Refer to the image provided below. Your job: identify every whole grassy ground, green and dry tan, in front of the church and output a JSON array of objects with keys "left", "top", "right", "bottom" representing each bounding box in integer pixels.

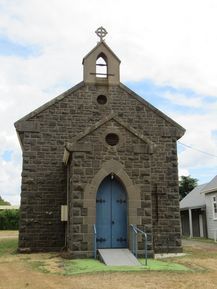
[{"left": 0, "top": 232, "right": 217, "bottom": 289}]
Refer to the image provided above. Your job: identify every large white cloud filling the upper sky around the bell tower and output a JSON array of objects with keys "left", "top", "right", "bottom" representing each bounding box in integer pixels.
[{"left": 0, "top": 0, "right": 217, "bottom": 96}]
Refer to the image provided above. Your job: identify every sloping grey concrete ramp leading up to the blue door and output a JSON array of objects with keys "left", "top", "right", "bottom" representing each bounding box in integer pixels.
[{"left": 98, "top": 249, "right": 141, "bottom": 266}]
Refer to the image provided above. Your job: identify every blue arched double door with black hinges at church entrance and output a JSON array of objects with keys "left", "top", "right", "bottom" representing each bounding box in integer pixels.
[{"left": 96, "top": 176, "right": 127, "bottom": 248}]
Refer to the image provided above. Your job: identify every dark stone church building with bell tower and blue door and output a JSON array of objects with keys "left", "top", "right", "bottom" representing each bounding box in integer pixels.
[{"left": 15, "top": 27, "right": 185, "bottom": 258}]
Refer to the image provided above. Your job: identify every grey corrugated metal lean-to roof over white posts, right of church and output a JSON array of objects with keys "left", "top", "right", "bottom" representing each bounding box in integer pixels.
[{"left": 180, "top": 183, "right": 207, "bottom": 209}]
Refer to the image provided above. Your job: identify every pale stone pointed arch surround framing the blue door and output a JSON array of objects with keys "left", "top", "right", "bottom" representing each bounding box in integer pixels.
[{"left": 84, "top": 160, "right": 141, "bottom": 232}]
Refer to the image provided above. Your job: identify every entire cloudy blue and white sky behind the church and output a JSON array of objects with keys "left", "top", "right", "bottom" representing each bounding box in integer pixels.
[{"left": 0, "top": 0, "right": 217, "bottom": 205}]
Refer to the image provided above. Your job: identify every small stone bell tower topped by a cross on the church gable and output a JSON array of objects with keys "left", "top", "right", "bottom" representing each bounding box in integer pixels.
[{"left": 83, "top": 27, "right": 121, "bottom": 85}]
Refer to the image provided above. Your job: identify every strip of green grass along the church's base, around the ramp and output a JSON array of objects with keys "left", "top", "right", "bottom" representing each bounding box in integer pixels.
[{"left": 0, "top": 234, "right": 191, "bottom": 275}]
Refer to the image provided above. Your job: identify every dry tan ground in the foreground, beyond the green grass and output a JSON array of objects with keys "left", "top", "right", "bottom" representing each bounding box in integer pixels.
[{"left": 0, "top": 235, "right": 217, "bottom": 289}]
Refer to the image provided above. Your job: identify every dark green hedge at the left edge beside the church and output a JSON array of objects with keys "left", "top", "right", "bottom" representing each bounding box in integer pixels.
[{"left": 0, "top": 209, "right": 20, "bottom": 230}]
